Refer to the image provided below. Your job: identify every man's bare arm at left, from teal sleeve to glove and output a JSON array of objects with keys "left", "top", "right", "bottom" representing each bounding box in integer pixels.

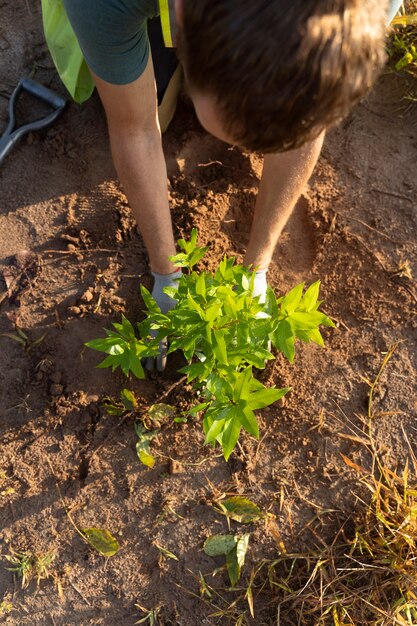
[{"left": 94, "top": 57, "right": 176, "bottom": 274}]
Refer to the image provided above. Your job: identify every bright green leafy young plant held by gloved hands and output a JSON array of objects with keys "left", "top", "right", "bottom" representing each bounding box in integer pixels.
[{"left": 86, "top": 230, "right": 334, "bottom": 460}]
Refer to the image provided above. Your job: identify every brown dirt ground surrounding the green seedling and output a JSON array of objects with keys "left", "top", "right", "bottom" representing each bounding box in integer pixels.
[{"left": 0, "top": 0, "right": 417, "bottom": 626}]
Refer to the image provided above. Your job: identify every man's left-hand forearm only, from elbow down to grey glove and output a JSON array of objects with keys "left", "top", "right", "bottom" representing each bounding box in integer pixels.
[{"left": 109, "top": 127, "right": 176, "bottom": 274}]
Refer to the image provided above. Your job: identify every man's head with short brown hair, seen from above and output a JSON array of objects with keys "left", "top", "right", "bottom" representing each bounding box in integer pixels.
[{"left": 177, "top": 0, "right": 387, "bottom": 152}]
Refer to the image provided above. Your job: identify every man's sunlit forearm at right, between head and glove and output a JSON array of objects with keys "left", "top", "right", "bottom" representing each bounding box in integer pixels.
[{"left": 244, "top": 133, "right": 324, "bottom": 268}]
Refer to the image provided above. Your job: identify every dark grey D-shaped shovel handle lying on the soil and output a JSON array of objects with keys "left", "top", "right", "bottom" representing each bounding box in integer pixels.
[{"left": 0, "top": 78, "right": 67, "bottom": 165}]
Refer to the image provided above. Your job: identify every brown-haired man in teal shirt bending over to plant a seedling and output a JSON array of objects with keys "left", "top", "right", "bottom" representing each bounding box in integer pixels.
[{"left": 58, "top": 0, "right": 400, "bottom": 369}]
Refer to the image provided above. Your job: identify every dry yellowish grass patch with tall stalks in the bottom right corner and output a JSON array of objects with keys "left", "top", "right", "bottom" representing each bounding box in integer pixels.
[{"left": 185, "top": 344, "right": 417, "bottom": 626}]
